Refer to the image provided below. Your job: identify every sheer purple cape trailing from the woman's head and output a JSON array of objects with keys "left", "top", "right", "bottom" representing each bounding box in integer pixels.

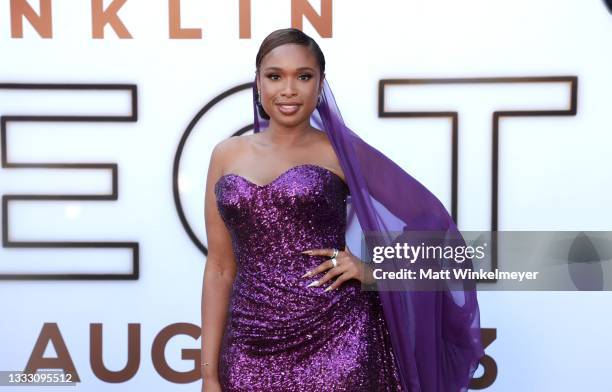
[{"left": 253, "top": 79, "right": 484, "bottom": 392}]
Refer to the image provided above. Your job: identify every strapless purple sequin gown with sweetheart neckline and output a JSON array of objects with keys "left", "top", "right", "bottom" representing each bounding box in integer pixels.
[{"left": 215, "top": 164, "right": 401, "bottom": 392}]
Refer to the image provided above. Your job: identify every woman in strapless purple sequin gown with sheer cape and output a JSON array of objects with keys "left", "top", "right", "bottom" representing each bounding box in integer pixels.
[{"left": 202, "top": 29, "right": 482, "bottom": 392}]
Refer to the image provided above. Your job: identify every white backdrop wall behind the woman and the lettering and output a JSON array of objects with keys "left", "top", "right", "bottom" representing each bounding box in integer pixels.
[{"left": 0, "top": 0, "right": 612, "bottom": 391}]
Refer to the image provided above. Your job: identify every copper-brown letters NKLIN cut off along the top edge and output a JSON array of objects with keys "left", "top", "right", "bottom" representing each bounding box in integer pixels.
[{"left": 9, "top": 0, "right": 332, "bottom": 39}]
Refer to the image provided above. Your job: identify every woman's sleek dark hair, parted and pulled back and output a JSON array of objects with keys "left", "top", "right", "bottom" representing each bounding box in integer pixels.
[{"left": 255, "top": 28, "right": 325, "bottom": 120}]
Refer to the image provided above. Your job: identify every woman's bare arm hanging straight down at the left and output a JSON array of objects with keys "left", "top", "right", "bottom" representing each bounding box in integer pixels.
[{"left": 201, "top": 140, "right": 236, "bottom": 389}]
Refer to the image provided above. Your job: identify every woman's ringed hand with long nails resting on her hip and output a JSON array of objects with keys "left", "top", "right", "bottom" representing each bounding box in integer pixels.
[{"left": 302, "top": 246, "right": 374, "bottom": 291}]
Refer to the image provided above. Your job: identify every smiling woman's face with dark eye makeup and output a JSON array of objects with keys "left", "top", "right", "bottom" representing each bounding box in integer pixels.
[{"left": 257, "top": 44, "right": 322, "bottom": 126}]
